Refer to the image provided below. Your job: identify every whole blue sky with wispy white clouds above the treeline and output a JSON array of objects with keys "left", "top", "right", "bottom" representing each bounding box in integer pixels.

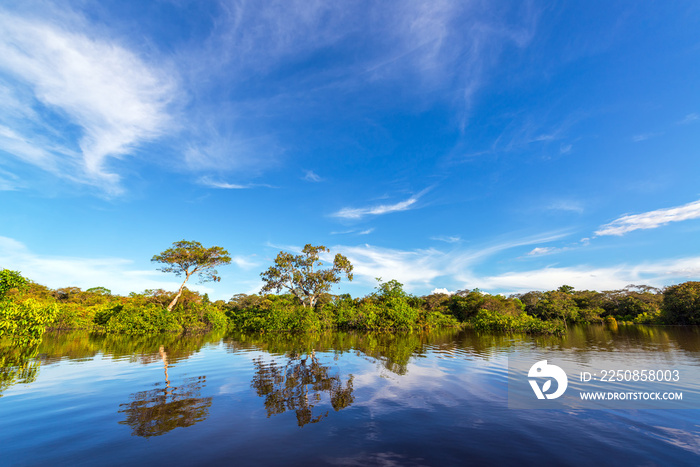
[{"left": 0, "top": 0, "right": 700, "bottom": 299}]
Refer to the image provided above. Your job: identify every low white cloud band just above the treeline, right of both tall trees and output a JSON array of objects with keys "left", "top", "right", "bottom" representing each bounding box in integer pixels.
[{"left": 262, "top": 233, "right": 700, "bottom": 293}]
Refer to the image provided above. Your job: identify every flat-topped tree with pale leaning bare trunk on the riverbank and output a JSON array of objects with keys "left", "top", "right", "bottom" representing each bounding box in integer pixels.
[{"left": 151, "top": 240, "right": 231, "bottom": 311}]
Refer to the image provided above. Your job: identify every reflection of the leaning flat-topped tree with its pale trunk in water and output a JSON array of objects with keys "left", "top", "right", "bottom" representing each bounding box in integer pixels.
[{"left": 119, "top": 346, "right": 212, "bottom": 438}]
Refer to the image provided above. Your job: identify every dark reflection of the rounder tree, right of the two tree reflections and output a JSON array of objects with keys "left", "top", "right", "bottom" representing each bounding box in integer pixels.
[{"left": 252, "top": 352, "right": 355, "bottom": 427}]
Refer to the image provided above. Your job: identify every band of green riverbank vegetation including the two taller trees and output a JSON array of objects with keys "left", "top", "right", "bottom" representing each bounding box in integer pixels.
[{"left": 0, "top": 240, "right": 700, "bottom": 340}]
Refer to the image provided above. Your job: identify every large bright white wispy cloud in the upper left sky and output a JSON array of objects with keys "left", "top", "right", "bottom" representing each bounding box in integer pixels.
[{"left": 0, "top": 10, "right": 178, "bottom": 193}]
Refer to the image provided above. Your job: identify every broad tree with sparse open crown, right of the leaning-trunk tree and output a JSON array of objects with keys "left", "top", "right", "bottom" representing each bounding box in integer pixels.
[{"left": 260, "top": 244, "right": 352, "bottom": 308}]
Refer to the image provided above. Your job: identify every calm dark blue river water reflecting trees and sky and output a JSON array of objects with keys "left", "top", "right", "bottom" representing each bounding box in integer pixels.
[{"left": 0, "top": 326, "right": 700, "bottom": 466}]
